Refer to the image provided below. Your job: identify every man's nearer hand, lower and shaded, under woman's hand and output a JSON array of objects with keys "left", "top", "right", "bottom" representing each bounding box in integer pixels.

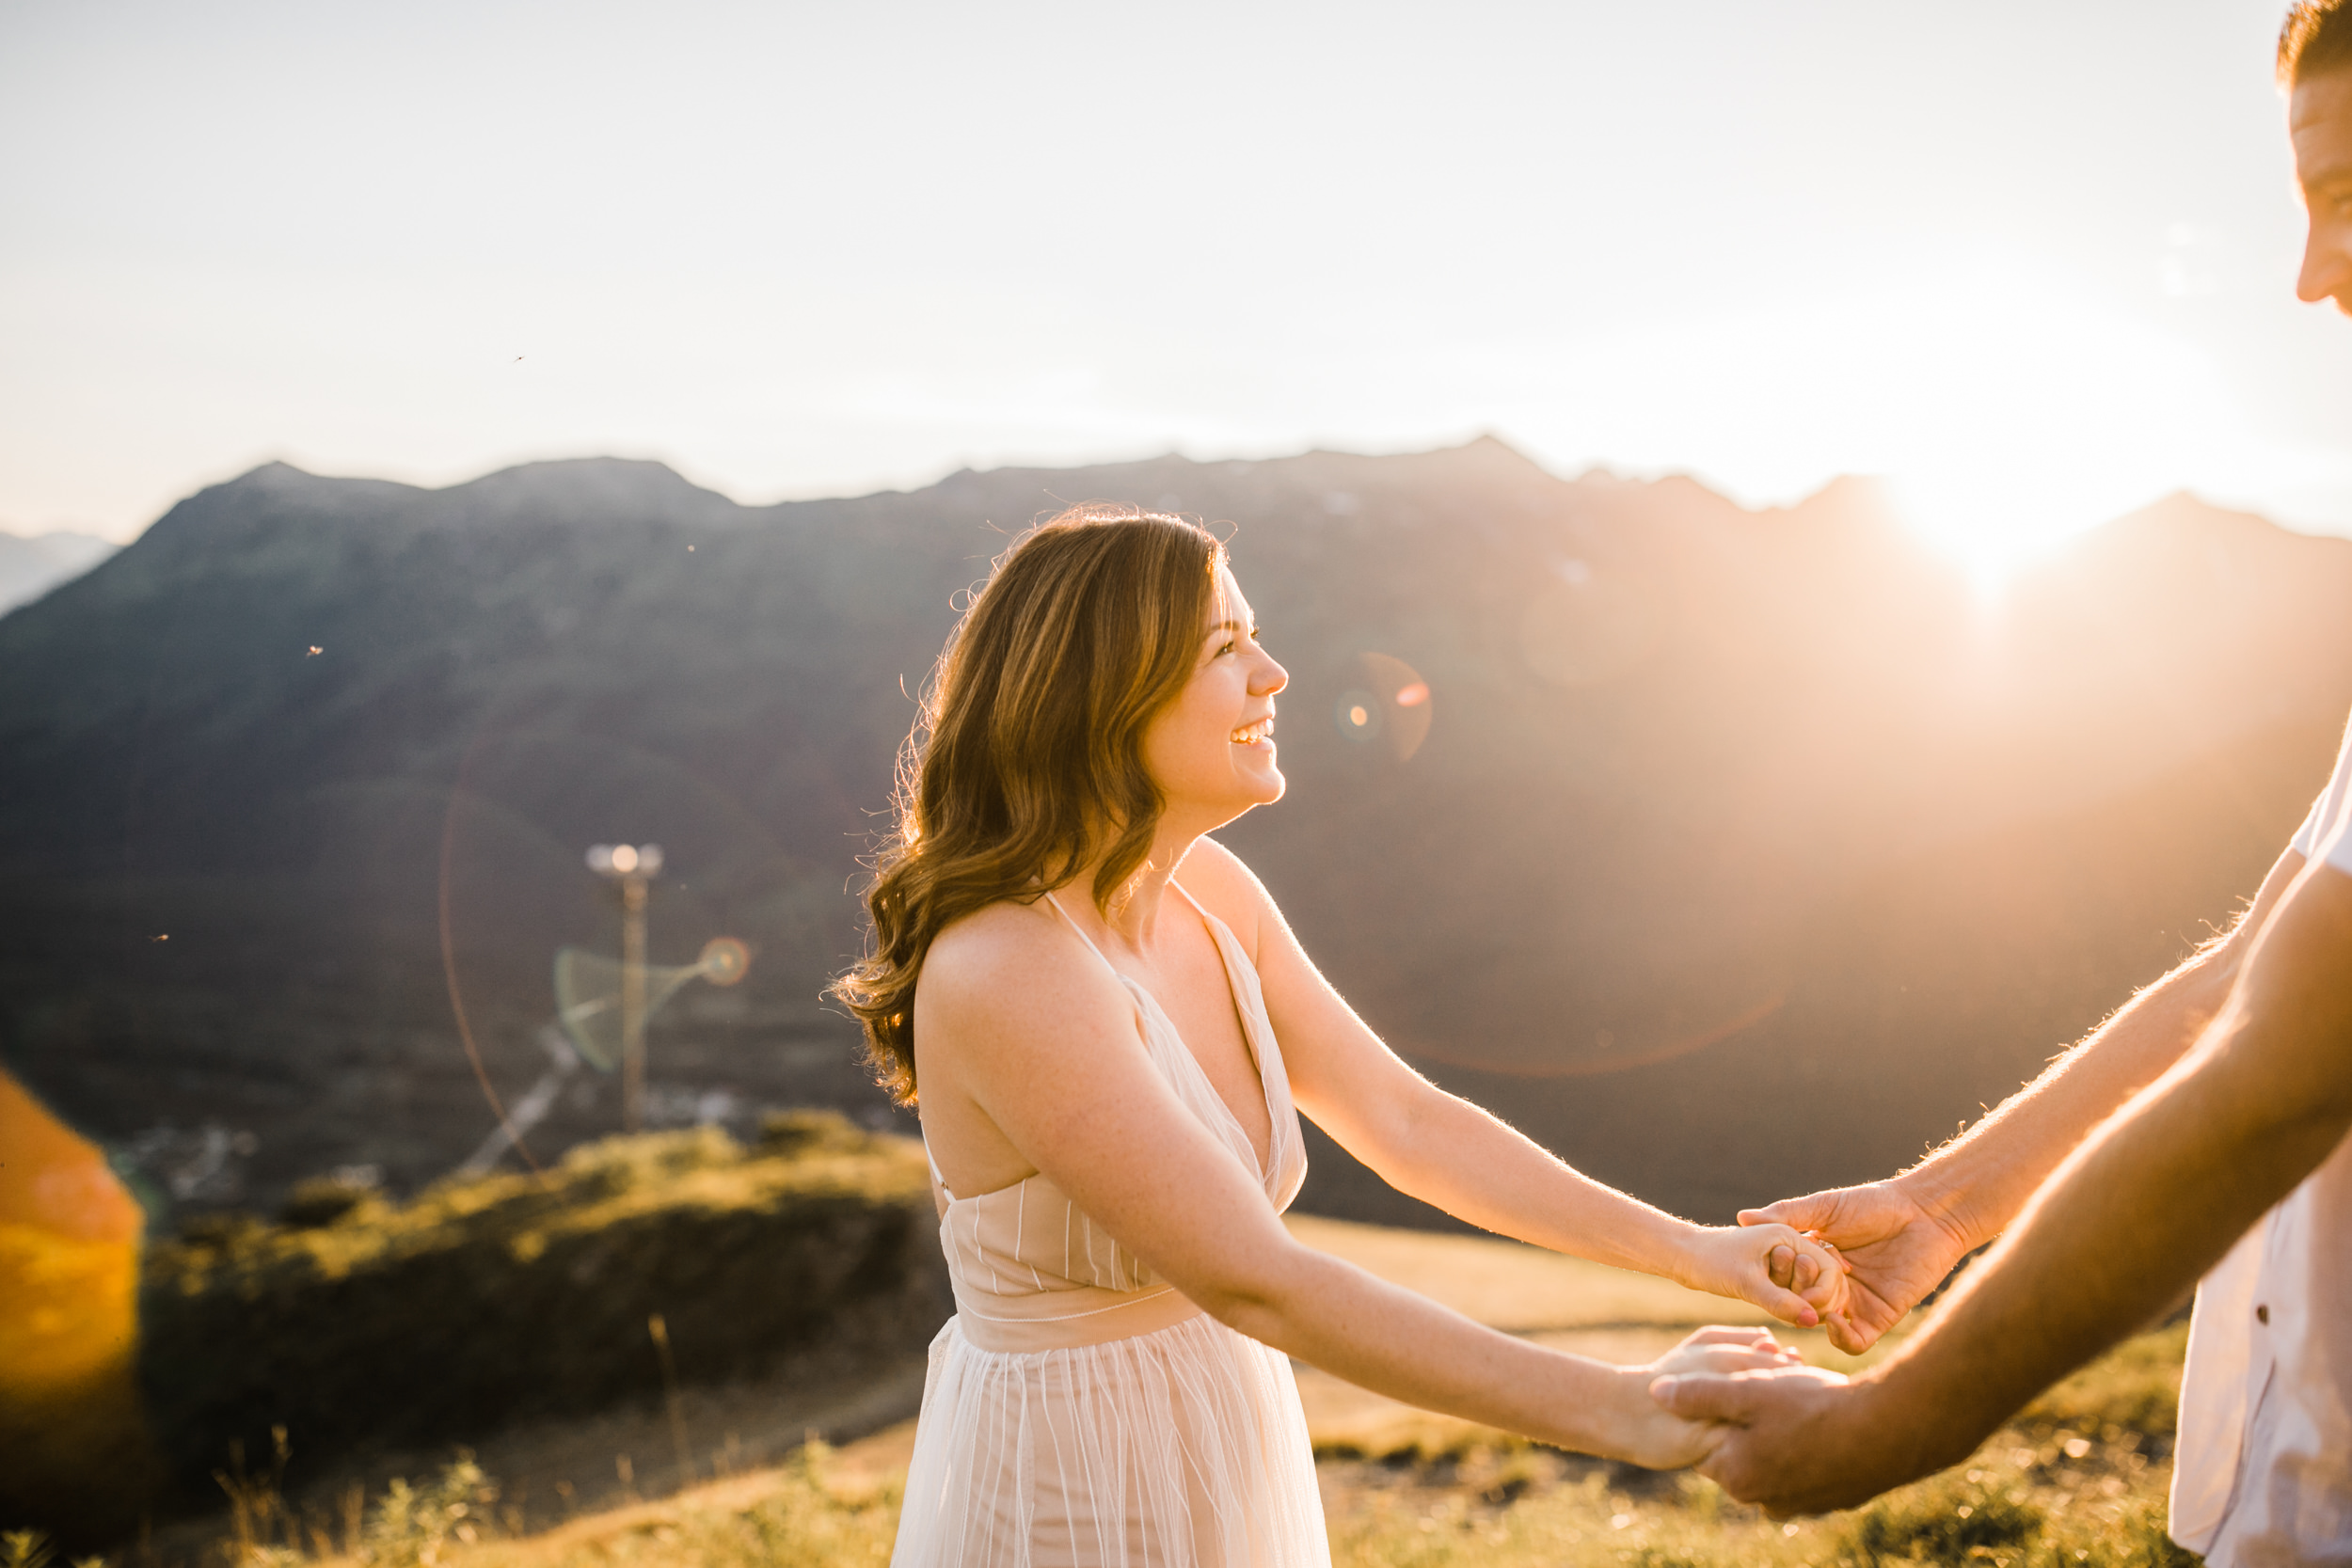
[{"left": 1649, "top": 1366, "right": 1936, "bottom": 1519}]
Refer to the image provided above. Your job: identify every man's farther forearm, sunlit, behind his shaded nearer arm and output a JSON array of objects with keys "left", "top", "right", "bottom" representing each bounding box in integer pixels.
[{"left": 1896, "top": 851, "right": 2303, "bottom": 1246}]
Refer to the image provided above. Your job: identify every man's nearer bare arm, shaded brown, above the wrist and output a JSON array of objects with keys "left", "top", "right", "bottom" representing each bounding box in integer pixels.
[{"left": 1866, "top": 867, "right": 2352, "bottom": 1472}]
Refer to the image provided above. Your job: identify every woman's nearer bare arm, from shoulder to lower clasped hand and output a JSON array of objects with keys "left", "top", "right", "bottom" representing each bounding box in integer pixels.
[{"left": 915, "top": 908, "right": 1783, "bottom": 1467}]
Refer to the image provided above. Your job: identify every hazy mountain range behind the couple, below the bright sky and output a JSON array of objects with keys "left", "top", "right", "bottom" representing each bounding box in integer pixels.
[{"left": 0, "top": 439, "right": 2352, "bottom": 1218}]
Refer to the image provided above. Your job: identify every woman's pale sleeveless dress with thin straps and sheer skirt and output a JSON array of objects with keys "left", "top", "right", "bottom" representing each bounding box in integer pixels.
[{"left": 892, "top": 884, "right": 1331, "bottom": 1568}]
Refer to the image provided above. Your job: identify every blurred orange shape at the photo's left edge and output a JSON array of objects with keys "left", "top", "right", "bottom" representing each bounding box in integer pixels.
[{"left": 0, "top": 1072, "right": 146, "bottom": 1540}]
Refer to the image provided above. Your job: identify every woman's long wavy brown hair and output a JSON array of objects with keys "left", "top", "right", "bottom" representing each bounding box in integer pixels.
[{"left": 828, "top": 503, "right": 1226, "bottom": 1105}]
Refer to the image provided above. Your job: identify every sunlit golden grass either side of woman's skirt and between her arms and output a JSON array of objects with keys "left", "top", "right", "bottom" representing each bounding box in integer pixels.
[{"left": 96, "top": 1220, "right": 2190, "bottom": 1568}]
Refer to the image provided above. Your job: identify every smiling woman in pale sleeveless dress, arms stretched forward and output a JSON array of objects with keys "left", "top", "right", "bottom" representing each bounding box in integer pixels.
[{"left": 835, "top": 508, "right": 1844, "bottom": 1568}]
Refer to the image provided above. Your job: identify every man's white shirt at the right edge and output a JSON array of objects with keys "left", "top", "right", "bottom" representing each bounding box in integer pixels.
[{"left": 2171, "top": 714, "right": 2352, "bottom": 1568}]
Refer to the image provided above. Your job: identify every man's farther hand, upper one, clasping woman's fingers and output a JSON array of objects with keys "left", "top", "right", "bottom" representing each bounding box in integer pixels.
[{"left": 1740, "top": 1180, "right": 1969, "bottom": 1356}]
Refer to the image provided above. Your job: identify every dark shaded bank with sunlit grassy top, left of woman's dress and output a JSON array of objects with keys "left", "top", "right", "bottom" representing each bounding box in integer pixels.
[{"left": 139, "top": 1115, "right": 948, "bottom": 1496}]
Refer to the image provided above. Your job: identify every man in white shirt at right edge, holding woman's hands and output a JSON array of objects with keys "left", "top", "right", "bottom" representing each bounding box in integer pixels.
[{"left": 1654, "top": 0, "right": 2352, "bottom": 1568}]
